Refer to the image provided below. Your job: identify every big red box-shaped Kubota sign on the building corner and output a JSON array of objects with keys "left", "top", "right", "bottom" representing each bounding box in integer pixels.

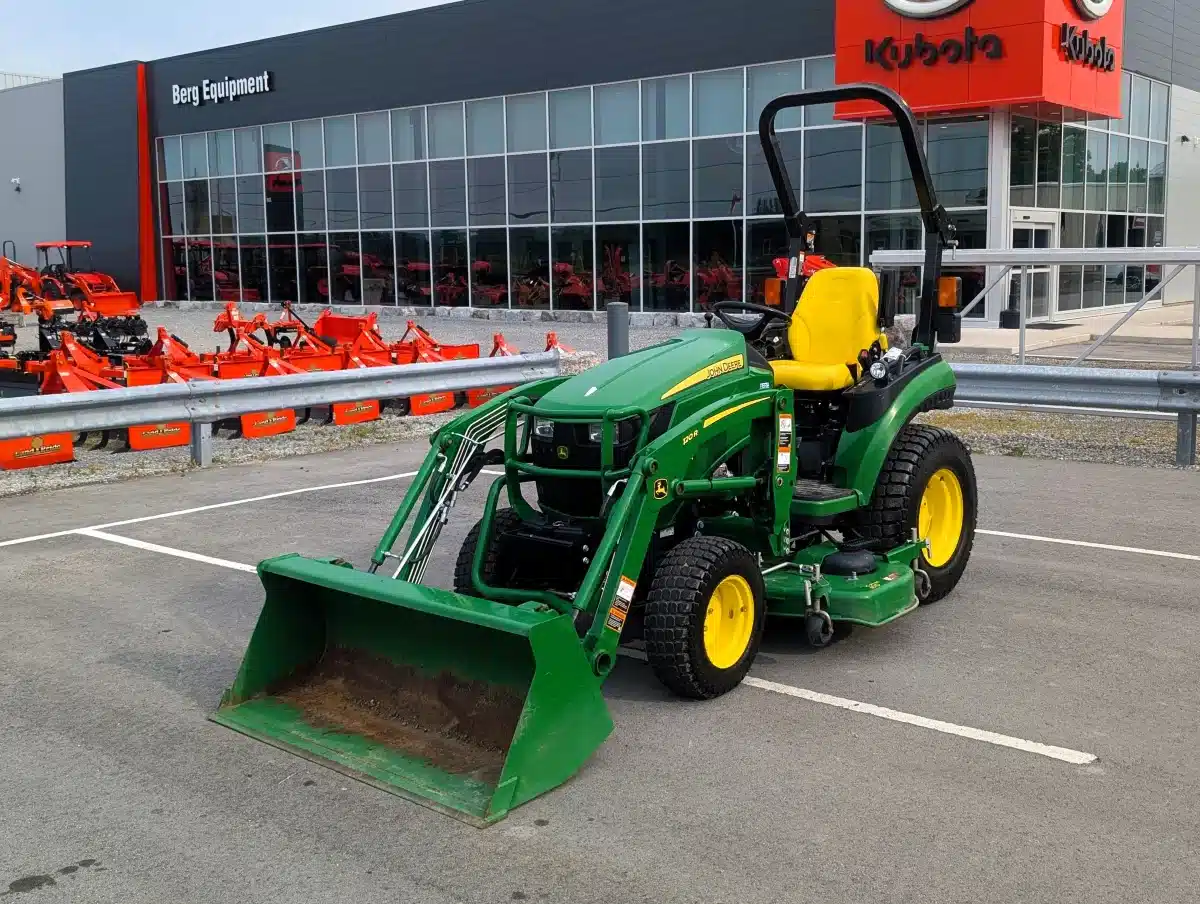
[{"left": 836, "top": 0, "right": 1124, "bottom": 116}]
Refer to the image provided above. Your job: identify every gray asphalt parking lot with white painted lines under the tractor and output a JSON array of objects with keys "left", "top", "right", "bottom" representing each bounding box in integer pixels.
[{"left": 0, "top": 443, "right": 1200, "bottom": 904}]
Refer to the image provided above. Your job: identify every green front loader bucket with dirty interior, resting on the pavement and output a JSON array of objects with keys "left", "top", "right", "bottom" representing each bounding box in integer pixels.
[{"left": 211, "top": 556, "right": 612, "bottom": 826}]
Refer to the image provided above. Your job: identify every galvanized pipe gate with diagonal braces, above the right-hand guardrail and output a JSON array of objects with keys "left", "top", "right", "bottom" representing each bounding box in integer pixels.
[{"left": 870, "top": 247, "right": 1200, "bottom": 370}]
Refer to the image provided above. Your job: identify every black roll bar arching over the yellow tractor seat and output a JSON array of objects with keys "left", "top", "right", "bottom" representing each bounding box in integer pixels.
[{"left": 758, "top": 83, "right": 956, "bottom": 348}]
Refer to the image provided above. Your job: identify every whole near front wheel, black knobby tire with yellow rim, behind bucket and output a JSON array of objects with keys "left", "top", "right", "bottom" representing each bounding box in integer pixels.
[{"left": 644, "top": 537, "right": 767, "bottom": 700}]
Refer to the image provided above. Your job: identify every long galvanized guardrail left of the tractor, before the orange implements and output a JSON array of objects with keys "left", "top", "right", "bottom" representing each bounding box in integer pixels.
[{"left": 0, "top": 352, "right": 560, "bottom": 466}]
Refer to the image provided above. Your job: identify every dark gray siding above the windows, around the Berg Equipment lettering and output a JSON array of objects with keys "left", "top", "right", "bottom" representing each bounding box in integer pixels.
[{"left": 151, "top": 0, "right": 834, "bottom": 134}]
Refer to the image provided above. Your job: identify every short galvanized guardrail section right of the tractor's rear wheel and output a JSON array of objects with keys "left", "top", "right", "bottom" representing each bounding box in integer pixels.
[{"left": 953, "top": 364, "right": 1200, "bottom": 467}]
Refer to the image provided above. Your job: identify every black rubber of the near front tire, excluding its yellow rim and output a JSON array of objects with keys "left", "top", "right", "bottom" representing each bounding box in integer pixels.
[{"left": 643, "top": 537, "right": 766, "bottom": 700}]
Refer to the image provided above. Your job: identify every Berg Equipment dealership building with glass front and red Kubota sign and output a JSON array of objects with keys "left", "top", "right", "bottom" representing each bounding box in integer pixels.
[{"left": 0, "top": 0, "right": 1200, "bottom": 325}]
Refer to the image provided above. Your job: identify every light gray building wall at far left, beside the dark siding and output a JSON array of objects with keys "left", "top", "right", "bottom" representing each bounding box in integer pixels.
[{"left": 0, "top": 79, "right": 66, "bottom": 264}]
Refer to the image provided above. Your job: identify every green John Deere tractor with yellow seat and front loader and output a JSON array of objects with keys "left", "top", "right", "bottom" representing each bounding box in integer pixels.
[{"left": 212, "top": 85, "right": 976, "bottom": 825}]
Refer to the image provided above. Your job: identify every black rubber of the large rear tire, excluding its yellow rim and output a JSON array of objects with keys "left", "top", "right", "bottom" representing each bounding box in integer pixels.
[{"left": 858, "top": 424, "right": 978, "bottom": 604}]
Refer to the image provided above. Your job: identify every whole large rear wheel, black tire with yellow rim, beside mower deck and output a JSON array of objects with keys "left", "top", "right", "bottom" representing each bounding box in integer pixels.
[{"left": 859, "top": 424, "right": 978, "bottom": 603}]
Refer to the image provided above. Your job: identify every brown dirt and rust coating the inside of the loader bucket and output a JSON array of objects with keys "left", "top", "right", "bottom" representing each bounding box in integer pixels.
[{"left": 271, "top": 649, "right": 524, "bottom": 784}]
